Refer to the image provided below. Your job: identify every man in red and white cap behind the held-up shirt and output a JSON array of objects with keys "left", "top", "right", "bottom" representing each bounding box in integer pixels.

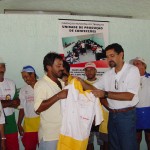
[{"left": 84, "top": 62, "right": 108, "bottom": 150}]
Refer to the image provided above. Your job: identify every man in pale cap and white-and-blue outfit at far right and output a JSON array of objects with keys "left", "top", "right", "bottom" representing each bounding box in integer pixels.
[{"left": 130, "top": 57, "right": 150, "bottom": 149}]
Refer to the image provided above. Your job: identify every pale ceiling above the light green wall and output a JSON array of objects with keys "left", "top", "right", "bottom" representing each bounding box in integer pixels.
[{"left": 0, "top": 0, "right": 150, "bottom": 20}]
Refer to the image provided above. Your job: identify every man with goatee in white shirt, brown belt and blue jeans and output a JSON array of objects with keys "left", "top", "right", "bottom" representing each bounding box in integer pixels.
[{"left": 78, "top": 43, "right": 140, "bottom": 150}]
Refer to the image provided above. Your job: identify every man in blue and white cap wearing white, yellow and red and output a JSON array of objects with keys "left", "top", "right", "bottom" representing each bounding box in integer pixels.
[{"left": 18, "top": 66, "right": 40, "bottom": 150}]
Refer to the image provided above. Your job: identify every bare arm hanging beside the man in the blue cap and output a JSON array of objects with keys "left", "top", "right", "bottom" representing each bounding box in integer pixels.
[{"left": 17, "top": 108, "right": 24, "bottom": 136}]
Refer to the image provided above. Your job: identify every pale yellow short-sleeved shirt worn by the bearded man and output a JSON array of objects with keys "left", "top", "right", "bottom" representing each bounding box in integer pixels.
[{"left": 34, "top": 75, "right": 64, "bottom": 141}]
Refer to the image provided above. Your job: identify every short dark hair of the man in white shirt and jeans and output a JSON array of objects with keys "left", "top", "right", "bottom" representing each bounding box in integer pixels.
[{"left": 105, "top": 43, "right": 124, "bottom": 54}]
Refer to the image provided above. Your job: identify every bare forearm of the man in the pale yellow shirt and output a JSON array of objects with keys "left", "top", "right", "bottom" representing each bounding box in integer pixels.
[{"left": 36, "top": 93, "right": 60, "bottom": 114}]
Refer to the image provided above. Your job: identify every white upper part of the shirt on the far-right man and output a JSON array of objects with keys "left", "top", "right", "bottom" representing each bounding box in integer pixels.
[{"left": 136, "top": 76, "right": 150, "bottom": 108}]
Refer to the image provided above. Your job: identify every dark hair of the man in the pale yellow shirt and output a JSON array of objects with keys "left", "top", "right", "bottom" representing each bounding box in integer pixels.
[{"left": 43, "top": 52, "right": 63, "bottom": 72}]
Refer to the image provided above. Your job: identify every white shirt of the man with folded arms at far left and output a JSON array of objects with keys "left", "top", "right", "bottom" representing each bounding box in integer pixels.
[{"left": 0, "top": 78, "right": 16, "bottom": 116}]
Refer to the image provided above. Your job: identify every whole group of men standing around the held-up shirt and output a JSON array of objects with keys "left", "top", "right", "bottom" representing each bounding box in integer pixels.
[{"left": 0, "top": 43, "right": 150, "bottom": 150}]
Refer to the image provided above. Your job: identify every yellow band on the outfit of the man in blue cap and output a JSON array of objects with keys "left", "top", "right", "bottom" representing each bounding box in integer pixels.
[{"left": 23, "top": 117, "right": 40, "bottom": 132}]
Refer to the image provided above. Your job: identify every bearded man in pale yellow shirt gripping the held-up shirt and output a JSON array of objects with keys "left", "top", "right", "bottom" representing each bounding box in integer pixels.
[{"left": 34, "top": 52, "right": 68, "bottom": 150}]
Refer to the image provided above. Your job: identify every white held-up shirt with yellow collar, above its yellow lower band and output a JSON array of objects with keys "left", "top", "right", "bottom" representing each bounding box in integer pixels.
[{"left": 61, "top": 79, "right": 103, "bottom": 141}]
